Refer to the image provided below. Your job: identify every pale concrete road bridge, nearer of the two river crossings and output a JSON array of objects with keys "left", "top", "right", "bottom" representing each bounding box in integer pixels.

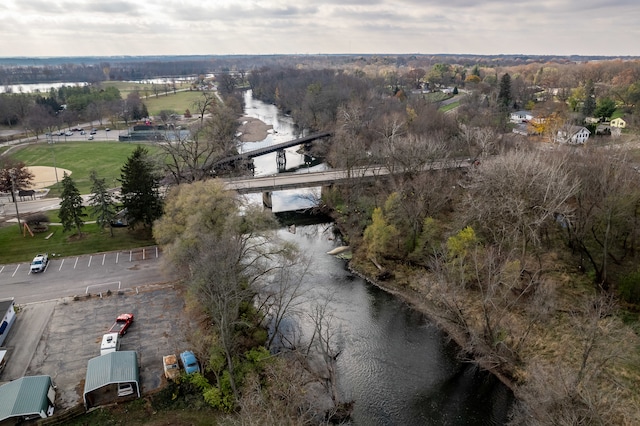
[{"left": 224, "top": 159, "right": 472, "bottom": 207}]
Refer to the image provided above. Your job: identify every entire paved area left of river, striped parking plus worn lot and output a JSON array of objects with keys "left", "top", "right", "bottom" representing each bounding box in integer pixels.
[{"left": 0, "top": 247, "right": 194, "bottom": 410}]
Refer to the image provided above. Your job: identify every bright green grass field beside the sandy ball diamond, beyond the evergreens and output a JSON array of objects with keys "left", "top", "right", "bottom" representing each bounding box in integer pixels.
[{"left": 10, "top": 142, "right": 160, "bottom": 196}]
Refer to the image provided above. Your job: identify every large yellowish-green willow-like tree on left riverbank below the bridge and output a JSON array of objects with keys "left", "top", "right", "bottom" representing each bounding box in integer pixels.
[{"left": 154, "top": 180, "right": 306, "bottom": 409}]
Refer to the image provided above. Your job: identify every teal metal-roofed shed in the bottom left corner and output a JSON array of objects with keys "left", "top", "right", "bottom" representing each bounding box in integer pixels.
[{"left": 0, "top": 376, "right": 56, "bottom": 422}]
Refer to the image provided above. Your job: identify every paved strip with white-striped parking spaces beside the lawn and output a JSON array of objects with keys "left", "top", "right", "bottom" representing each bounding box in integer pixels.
[{"left": 0, "top": 247, "right": 172, "bottom": 304}]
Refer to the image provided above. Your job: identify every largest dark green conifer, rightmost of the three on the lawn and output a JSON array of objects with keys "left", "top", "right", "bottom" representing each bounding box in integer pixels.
[{"left": 120, "top": 146, "right": 162, "bottom": 228}]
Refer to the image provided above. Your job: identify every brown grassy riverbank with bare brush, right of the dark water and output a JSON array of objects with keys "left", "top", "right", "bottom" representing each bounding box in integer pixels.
[{"left": 342, "top": 230, "right": 640, "bottom": 425}]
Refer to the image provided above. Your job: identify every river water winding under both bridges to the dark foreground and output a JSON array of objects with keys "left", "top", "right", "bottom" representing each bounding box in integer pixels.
[{"left": 246, "top": 92, "right": 513, "bottom": 426}]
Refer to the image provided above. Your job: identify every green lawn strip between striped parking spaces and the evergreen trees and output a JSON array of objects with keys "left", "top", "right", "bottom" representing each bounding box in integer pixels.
[{"left": 0, "top": 221, "right": 155, "bottom": 264}]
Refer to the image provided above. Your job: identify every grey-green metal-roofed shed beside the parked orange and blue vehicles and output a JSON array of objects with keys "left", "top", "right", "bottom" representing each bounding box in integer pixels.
[{"left": 83, "top": 351, "right": 140, "bottom": 408}]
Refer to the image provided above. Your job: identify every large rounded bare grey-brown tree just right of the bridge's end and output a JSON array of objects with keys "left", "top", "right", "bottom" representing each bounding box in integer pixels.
[{"left": 466, "top": 151, "right": 578, "bottom": 256}]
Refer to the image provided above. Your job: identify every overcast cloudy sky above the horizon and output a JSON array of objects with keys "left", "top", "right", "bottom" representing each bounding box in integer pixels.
[{"left": 0, "top": 0, "right": 640, "bottom": 57}]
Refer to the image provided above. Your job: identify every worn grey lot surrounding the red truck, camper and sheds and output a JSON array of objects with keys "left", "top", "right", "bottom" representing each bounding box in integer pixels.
[{"left": 0, "top": 284, "right": 191, "bottom": 410}]
